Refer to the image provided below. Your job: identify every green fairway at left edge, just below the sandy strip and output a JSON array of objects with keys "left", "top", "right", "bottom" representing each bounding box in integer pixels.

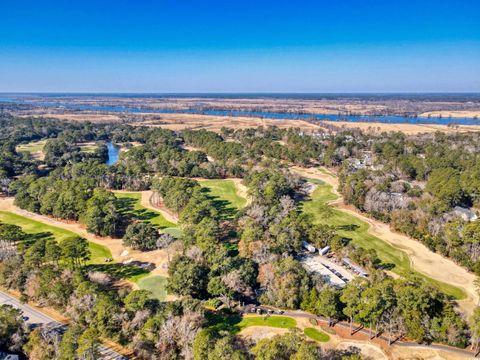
[{"left": 0, "top": 211, "right": 112, "bottom": 264}]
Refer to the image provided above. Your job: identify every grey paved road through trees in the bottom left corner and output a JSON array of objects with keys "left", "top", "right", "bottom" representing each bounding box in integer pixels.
[{"left": 0, "top": 291, "right": 128, "bottom": 360}]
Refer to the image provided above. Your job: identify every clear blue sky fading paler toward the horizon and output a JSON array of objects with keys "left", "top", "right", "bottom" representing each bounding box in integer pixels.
[{"left": 0, "top": 0, "right": 480, "bottom": 92}]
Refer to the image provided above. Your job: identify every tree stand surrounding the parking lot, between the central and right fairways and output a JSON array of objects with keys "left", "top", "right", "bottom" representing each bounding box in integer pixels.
[{"left": 156, "top": 169, "right": 469, "bottom": 347}]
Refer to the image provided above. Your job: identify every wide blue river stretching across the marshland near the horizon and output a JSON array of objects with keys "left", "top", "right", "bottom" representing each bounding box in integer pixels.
[{"left": 0, "top": 99, "right": 480, "bottom": 125}]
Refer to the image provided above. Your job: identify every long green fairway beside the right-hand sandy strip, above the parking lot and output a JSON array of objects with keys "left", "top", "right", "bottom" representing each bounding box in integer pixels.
[{"left": 303, "top": 180, "right": 465, "bottom": 300}]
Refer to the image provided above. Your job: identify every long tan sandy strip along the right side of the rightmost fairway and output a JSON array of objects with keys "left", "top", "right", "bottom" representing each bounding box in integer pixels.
[{"left": 292, "top": 167, "right": 479, "bottom": 315}]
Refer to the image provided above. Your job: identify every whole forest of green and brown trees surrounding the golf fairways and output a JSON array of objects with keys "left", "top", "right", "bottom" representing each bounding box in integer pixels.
[{"left": 0, "top": 114, "right": 480, "bottom": 360}]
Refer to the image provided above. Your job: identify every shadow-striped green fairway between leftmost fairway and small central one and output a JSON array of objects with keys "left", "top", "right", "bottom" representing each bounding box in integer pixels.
[{"left": 115, "top": 192, "right": 181, "bottom": 237}]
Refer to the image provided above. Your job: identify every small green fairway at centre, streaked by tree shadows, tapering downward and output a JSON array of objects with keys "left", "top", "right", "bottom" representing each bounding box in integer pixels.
[{"left": 199, "top": 180, "right": 247, "bottom": 219}]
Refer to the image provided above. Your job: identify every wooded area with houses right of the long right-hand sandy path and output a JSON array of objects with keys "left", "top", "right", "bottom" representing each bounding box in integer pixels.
[{"left": 340, "top": 133, "right": 480, "bottom": 274}]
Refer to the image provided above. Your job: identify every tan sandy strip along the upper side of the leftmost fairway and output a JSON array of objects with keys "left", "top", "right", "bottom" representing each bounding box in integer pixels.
[{"left": 0, "top": 198, "right": 176, "bottom": 276}]
